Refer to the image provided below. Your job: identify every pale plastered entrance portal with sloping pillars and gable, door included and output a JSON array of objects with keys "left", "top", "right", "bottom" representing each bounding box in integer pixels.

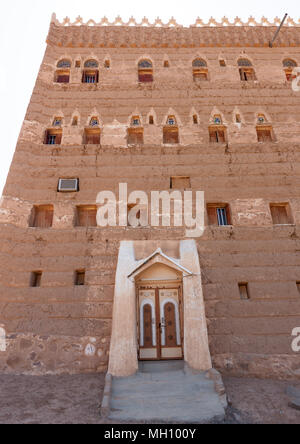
[{"left": 108, "top": 240, "right": 212, "bottom": 377}]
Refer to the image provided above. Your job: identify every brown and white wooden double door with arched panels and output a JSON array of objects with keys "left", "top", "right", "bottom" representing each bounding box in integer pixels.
[{"left": 137, "top": 286, "right": 183, "bottom": 361}]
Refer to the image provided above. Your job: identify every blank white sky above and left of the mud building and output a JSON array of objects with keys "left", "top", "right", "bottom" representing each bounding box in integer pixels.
[{"left": 0, "top": 0, "right": 300, "bottom": 194}]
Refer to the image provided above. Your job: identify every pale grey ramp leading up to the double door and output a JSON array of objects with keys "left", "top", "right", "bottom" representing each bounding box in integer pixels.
[{"left": 109, "top": 361, "right": 226, "bottom": 423}]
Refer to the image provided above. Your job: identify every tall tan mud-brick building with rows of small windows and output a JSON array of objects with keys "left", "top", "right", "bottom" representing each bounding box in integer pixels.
[{"left": 0, "top": 16, "right": 300, "bottom": 377}]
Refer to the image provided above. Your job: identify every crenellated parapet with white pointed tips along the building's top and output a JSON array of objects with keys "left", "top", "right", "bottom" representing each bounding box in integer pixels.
[{"left": 47, "top": 14, "right": 300, "bottom": 48}]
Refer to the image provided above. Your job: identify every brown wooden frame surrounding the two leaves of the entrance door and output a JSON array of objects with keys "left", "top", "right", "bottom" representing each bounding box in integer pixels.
[{"left": 136, "top": 281, "right": 184, "bottom": 361}]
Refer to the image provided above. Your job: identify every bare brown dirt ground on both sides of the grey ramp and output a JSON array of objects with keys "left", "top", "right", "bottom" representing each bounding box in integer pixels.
[{"left": 0, "top": 374, "right": 300, "bottom": 424}]
